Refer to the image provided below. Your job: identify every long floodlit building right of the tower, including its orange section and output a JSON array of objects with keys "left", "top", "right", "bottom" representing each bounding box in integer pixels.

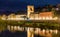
[{"left": 28, "top": 7, "right": 58, "bottom": 20}]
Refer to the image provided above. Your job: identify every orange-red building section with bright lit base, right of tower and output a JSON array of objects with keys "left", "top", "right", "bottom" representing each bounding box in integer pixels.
[{"left": 39, "top": 12, "right": 54, "bottom": 20}]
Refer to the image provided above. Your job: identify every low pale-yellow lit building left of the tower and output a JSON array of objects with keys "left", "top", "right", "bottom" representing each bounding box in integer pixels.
[{"left": 7, "top": 13, "right": 26, "bottom": 20}]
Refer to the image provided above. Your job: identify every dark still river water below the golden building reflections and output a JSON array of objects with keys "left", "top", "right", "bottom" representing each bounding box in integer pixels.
[{"left": 0, "top": 30, "right": 40, "bottom": 37}]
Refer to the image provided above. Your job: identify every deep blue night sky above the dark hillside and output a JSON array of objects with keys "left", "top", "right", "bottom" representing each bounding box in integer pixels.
[{"left": 0, "top": 0, "right": 60, "bottom": 11}]
